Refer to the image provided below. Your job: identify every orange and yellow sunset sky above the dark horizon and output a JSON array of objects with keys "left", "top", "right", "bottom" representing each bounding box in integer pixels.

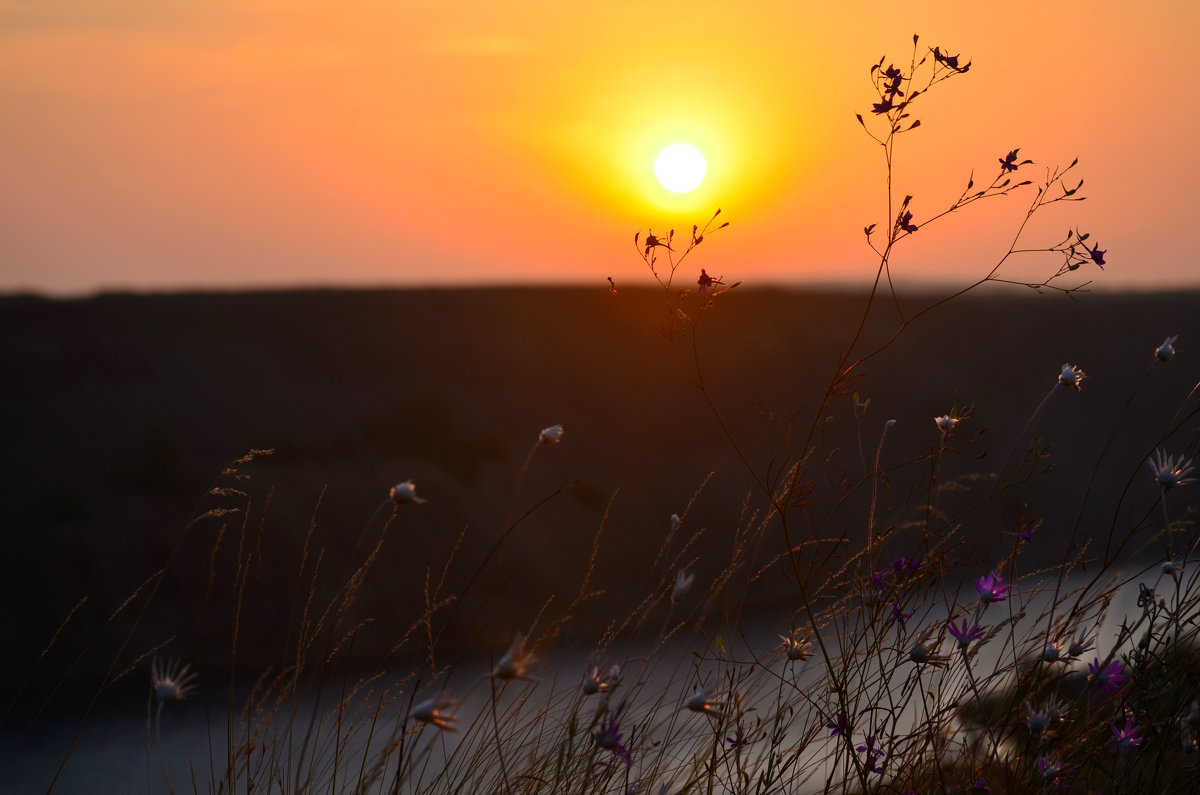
[{"left": 0, "top": 0, "right": 1200, "bottom": 294}]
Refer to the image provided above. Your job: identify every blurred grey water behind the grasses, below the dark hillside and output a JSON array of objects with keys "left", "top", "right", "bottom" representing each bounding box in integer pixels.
[{"left": 0, "top": 567, "right": 1180, "bottom": 794}]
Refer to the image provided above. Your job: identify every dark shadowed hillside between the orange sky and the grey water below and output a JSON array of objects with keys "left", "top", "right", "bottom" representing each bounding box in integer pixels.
[{"left": 0, "top": 287, "right": 1200, "bottom": 680}]
